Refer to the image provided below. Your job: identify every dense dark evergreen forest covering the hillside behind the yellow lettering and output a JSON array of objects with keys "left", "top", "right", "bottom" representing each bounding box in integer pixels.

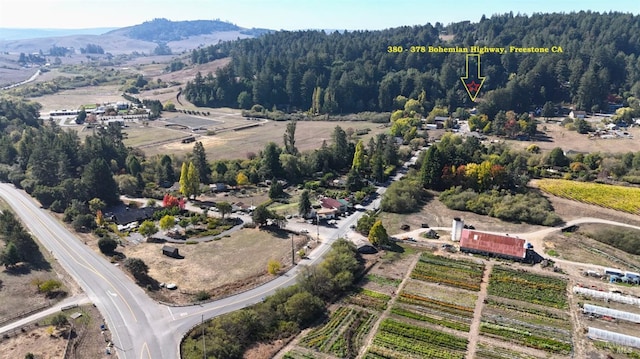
[{"left": 184, "top": 12, "right": 640, "bottom": 118}]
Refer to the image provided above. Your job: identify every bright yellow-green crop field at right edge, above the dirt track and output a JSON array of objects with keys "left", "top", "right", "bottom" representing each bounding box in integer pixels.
[{"left": 538, "top": 179, "right": 640, "bottom": 214}]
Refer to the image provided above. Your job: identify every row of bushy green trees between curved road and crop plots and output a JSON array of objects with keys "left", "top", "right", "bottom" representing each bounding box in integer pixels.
[{"left": 180, "top": 239, "right": 363, "bottom": 359}]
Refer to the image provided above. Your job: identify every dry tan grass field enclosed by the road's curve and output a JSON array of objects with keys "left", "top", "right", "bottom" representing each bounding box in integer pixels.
[{"left": 123, "top": 229, "right": 306, "bottom": 293}]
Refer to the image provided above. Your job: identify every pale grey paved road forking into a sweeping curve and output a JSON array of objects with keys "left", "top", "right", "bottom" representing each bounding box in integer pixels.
[{"left": 0, "top": 183, "right": 360, "bottom": 359}]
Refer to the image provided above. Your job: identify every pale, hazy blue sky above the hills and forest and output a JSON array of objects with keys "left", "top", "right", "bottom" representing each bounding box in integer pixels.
[{"left": 0, "top": 0, "right": 640, "bottom": 30}]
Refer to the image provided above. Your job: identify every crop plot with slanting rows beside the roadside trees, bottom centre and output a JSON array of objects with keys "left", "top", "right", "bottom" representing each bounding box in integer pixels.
[{"left": 299, "top": 307, "right": 377, "bottom": 358}]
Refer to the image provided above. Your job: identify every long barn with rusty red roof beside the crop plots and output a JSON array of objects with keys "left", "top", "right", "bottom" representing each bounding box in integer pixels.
[{"left": 460, "top": 229, "right": 528, "bottom": 260}]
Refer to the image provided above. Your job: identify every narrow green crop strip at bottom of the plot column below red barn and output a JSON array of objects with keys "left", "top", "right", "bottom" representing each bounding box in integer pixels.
[{"left": 480, "top": 323, "right": 571, "bottom": 355}]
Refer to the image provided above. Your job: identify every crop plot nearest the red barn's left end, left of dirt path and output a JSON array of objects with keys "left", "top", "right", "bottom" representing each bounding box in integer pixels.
[{"left": 411, "top": 253, "right": 484, "bottom": 291}]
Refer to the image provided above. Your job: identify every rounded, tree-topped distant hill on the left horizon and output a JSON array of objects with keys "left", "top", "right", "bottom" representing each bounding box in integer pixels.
[{"left": 108, "top": 19, "right": 271, "bottom": 43}]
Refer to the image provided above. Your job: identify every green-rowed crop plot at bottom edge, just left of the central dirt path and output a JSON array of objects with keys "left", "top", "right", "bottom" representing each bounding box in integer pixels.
[{"left": 365, "top": 319, "right": 468, "bottom": 359}]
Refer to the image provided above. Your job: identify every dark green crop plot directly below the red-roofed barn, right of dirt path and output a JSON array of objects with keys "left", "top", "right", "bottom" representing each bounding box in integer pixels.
[{"left": 488, "top": 267, "right": 567, "bottom": 308}]
